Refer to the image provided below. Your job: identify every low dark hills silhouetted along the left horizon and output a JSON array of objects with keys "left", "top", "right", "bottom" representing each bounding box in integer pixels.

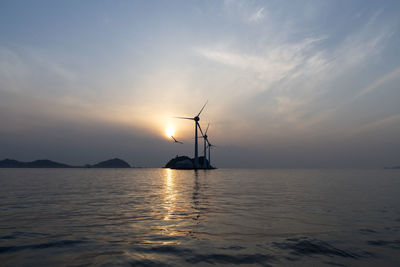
[{"left": 0, "top": 158, "right": 131, "bottom": 168}]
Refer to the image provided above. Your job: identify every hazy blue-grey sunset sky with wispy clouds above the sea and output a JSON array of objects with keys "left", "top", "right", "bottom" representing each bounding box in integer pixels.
[{"left": 0, "top": 0, "right": 400, "bottom": 168}]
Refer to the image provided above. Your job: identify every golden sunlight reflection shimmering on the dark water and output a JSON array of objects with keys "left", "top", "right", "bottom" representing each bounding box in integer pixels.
[{"left": 128, "top": 169, "right": 208, "bottom": 251}]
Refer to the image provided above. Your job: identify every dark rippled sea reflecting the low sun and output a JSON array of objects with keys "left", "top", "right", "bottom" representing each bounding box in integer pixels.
[{"left": 0, "top": 169, "right": 400, "bottom": 266}]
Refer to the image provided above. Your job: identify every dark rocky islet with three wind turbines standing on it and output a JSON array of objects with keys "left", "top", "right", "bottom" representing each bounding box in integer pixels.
[{"left": 171, "top": 101, "right": 215, "bottom": 170}]
